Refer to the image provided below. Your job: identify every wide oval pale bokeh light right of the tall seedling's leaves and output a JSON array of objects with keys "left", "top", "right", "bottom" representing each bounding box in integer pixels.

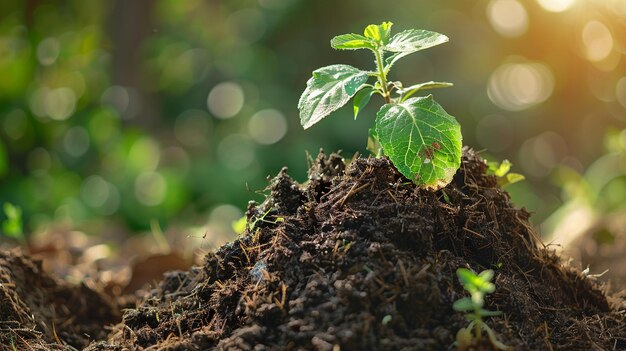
[{"left": 487, "top": 62, "right": 554, "bottom": 111}]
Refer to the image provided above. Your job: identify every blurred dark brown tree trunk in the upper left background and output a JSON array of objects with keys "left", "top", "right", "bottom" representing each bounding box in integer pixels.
[{"left": 108, "top": 0, "right": 159, "bottom": 129}]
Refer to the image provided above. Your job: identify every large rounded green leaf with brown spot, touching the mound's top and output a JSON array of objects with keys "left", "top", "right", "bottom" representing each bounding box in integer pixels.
[{"left": 376, "top": 95, "right": 462, "bottom": 190}]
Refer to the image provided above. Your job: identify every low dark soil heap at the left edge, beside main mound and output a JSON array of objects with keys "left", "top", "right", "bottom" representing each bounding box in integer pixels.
[{"left": 0, "top": 251, "right": 120, "bottom": 351}]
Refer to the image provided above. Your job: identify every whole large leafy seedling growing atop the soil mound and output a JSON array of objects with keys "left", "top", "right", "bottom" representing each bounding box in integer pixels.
[{"left": 298, "top": 22, "right": 462, "bottom": 190}]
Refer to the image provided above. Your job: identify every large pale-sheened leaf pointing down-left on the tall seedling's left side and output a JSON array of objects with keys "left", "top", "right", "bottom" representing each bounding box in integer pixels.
[{"left": 298, "top": 65, "right": 368, "bottom": 129}]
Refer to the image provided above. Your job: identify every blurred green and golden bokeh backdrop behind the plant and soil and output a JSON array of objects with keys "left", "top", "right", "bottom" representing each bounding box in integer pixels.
[{"left": 0, "top": 0, "right": 626, "bottom": 242}]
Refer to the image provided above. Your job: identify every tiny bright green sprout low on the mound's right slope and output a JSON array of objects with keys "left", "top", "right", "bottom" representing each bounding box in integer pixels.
[{"left": 452, "top": 268, "right": 509, "bottom": 350}]
